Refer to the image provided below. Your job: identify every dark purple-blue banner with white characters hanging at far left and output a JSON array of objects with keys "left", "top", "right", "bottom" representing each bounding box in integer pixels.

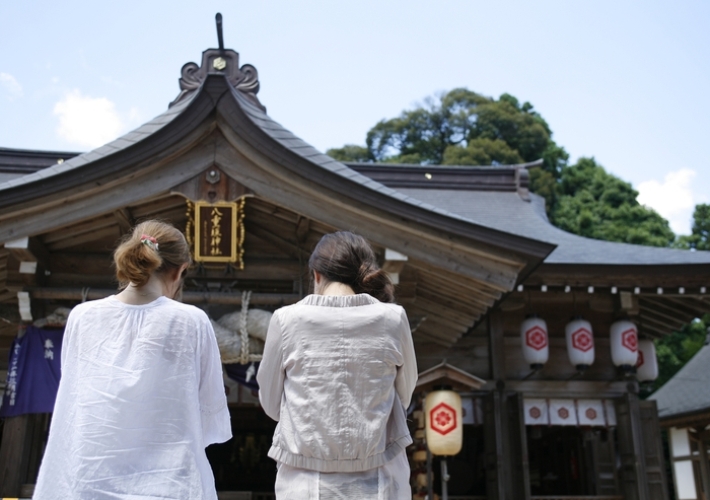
[{"left": 0, "top": 326, "right": 64, "bottom": 417}]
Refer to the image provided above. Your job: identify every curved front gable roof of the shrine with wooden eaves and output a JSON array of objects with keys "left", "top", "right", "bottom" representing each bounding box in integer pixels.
[{"left": 0, "top": 50, "right": 555, "bottom": 345}]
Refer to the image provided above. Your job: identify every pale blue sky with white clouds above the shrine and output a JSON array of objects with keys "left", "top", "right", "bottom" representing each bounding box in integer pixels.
[{"left": 0, "top": 0, "right": 710, "bottom": 233}]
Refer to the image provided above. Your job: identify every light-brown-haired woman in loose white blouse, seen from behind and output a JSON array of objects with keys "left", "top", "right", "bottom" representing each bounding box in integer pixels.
[{"left": 33, "top": 221, "right": 232, "bottom": 500}]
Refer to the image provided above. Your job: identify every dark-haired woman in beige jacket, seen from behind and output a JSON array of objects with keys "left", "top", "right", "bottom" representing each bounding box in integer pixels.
[{"left": 257, "top": 231, "right": 417, "bottom": 500}]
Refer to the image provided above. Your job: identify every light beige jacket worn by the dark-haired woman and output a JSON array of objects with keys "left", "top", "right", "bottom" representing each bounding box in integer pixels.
[{"left": 257, "top": 294, "right": 417, "bottom": 472}]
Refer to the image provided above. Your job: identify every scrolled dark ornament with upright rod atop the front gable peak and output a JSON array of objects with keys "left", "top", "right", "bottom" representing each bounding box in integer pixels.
[{"left": 168, "top": 13, "right": 266, "bottom": 111}]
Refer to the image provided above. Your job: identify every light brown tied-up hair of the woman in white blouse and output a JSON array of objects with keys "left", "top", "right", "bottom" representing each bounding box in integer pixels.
[{"left": 113, "top": 220, "right": 191, "bottom": 288}]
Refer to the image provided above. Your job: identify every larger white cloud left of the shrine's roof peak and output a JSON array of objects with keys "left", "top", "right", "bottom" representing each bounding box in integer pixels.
[{"left": 54, "top": 89, "right": 124, "bottom": 148}]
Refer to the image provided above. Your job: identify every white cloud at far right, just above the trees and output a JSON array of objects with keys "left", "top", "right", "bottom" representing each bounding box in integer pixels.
[{"left": 637, "top": 168, "right": 700, "bottom": 234}]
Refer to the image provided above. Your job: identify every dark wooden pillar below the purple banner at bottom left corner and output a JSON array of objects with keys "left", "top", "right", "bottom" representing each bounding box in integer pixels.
[{"left": 0, "top": 415, "right": 32, "bottom": 498}]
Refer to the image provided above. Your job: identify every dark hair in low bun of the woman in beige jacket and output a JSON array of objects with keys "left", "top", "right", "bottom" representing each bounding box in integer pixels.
[{"left": 308, "top": 231, "right": 394, "bottom": 302}]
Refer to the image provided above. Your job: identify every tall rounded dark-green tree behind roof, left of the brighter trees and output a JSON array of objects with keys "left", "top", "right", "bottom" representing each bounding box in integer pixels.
[{"left": 329, "top": 88, "right": 566, "bottom": 168}]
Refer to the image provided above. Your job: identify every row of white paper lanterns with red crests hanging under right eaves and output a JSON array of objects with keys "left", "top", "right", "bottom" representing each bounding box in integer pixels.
[{"left": 520, "top": 315, "right": 658, "bottom": 382}]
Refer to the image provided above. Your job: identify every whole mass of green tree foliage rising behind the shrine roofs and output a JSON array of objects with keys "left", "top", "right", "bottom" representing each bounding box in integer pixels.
[{"left": 328, "top": 88, "right": 680, "bottom": 248}]
